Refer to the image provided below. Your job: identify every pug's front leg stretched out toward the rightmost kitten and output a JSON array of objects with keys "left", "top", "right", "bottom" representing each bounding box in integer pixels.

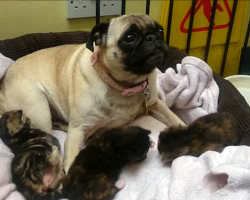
[{"left": 149, "top": 98, "right": 186, "bottom": 126}]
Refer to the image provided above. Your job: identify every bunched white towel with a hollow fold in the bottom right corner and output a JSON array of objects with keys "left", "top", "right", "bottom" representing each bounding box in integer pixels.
[{"left": 169, "top": 146, "right": 250, "bottom": 200}]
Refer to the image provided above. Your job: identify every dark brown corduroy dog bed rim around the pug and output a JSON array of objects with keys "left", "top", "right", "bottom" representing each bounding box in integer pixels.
[{"left": 0, "top": 31, "right": 250, "bottom": 145}]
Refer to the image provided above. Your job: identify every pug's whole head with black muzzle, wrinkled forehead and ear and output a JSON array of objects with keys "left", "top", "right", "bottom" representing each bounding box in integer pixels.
[{"left": 87, "top": 14, "right": 168, "bottom": 80}]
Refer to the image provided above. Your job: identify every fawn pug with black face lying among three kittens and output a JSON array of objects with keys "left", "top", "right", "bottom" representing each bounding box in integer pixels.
[{"left": 0, "top": 14, "right": 185, "bottom": 172}]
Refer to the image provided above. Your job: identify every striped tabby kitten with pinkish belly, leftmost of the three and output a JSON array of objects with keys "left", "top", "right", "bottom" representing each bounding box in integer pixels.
[{"left": 0, "top": 110, "right": 64, "bottom": 200}]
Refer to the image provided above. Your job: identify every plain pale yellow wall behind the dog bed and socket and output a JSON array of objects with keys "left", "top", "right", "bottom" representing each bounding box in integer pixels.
[{"left": 0, "top": 0, "right": 162, "bottom": 40}]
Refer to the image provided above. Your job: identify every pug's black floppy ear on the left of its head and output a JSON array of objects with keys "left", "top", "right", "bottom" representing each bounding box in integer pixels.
[{"left": 86, "top": 22, "right": 110, "bottom": 52}]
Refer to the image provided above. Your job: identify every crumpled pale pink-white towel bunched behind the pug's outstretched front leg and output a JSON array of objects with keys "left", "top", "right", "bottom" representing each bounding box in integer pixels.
[{"left": 157, "top": 56, "right": 219, "bottom": 124}]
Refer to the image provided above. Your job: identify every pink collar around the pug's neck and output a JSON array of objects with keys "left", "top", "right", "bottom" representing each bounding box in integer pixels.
[{"left": 91, "top": 50, "right": 148, "bottom": 96}]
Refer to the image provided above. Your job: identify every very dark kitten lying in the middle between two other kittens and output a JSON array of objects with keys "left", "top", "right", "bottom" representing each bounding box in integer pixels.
[{"left": 59, "top": 126, "right": 153, "bottom": 200}]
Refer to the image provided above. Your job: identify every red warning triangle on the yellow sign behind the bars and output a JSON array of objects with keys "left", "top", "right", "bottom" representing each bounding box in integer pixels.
[{"left": 180, "top": 0, "right": 232, "bottom": 33}]
